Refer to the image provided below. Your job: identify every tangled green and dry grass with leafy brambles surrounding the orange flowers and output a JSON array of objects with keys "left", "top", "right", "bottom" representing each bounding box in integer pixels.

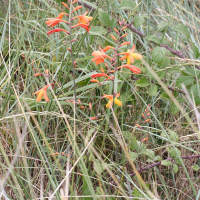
[{"left": 0, "top": 0, "right": 200, "bottom": 200}]
